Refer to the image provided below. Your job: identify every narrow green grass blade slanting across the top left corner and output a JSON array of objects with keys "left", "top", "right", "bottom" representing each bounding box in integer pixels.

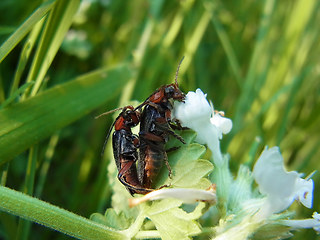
[{"left": 0, "top": 0, "right": 55, "bottom": 63}]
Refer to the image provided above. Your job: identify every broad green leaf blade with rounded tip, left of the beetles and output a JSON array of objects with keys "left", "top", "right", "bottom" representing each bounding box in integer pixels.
[{"left": 0, "top": 66, "right": 131, "bottom": 164}]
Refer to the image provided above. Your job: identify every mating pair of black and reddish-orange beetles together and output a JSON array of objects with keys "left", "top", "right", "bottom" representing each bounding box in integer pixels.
[{"left": 99, "top": 60, "right": 185, "bottom": 195}]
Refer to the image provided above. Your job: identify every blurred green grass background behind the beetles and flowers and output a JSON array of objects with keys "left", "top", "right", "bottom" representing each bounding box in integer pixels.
[{"left": 0, "top": 0, "right": 320, "bottom": 239}]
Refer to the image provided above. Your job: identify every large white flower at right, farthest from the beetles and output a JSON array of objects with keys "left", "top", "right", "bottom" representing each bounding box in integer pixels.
[{"left": 253, "top": 147, "right": 313, "bottom": 218}]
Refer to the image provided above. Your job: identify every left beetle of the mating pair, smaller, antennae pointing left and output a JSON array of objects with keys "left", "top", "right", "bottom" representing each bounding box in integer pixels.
[{"left": 96, "top": 106, "right": 152, "bottom": 195}]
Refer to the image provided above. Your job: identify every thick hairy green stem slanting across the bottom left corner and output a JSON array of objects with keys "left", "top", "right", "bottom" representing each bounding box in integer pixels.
[{"left": 0, "top": 186, "right": 128, "bottom": 240}]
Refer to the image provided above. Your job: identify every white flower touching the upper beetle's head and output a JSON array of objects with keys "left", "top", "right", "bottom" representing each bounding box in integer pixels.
[{"left": 172, "top": 89, "right": 232, "bottom": 166}]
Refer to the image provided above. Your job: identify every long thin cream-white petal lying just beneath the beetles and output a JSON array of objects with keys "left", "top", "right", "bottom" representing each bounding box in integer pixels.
[{"left": 129, "top": 187, "right": 217, "bottom": 207}]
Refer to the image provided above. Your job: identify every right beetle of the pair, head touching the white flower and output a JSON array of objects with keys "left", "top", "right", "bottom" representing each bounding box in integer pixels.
[{"left": 135, "top": 58, "right": 185, "bottom": 188}]
